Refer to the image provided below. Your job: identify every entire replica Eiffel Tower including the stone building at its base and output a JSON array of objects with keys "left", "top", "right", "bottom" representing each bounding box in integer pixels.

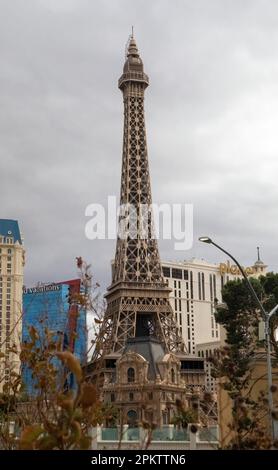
[{"left": 88, "top": 34, "right": 203, "bottom": 423}]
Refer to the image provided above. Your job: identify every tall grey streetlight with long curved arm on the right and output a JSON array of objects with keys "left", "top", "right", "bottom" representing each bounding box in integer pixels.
[{"left": 199, "top": 237, "right": 278, "bottom": 442}]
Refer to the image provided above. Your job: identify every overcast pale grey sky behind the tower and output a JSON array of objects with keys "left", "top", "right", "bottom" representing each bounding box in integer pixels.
[{"left": 0, "top": 0, "right": 278, "bottom": 289}]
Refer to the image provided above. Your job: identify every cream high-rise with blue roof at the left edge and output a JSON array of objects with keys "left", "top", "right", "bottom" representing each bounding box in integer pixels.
[{"left": 0, "top": 219, "right": 24, "bottom": 391}]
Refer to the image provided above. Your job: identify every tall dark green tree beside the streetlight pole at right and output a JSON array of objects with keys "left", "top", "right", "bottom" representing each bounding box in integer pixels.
[{"left": 210, "top": 273, "right": 278, "bottom": 449}]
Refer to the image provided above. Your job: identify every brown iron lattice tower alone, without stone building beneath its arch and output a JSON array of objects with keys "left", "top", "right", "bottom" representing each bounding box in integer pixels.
[{"left": 92, "top": 36, "right": 186, "bottom": 361}]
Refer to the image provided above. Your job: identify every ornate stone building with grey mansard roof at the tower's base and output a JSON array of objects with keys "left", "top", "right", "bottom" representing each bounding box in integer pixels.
[{"left": 103, "top": 338, "right": 204, "bottom": 426}]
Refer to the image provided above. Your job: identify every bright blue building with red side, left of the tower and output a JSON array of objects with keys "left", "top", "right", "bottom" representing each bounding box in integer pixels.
[{"left": 22, "top": 279, "right": 87, "bottom": 396}]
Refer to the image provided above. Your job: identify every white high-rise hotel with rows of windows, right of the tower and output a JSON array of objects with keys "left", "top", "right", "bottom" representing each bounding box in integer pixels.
[{"left": 162, "top": 254, "right": 267, "bottom": 392}]
